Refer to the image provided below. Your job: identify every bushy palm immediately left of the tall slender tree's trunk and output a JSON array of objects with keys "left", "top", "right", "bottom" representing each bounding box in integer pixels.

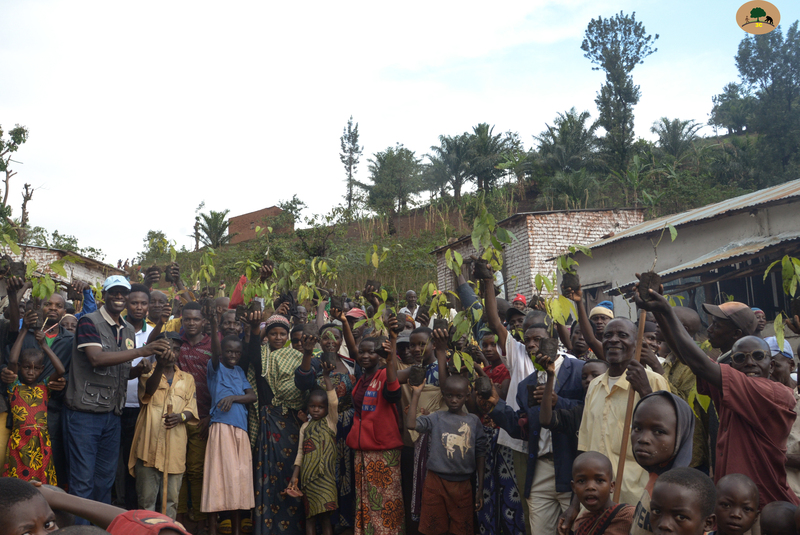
[{"left": 534, "top": 108, "right": 603, "bottom": 173}]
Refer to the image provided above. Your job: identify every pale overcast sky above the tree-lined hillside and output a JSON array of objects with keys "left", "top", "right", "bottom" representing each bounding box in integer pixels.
[{"left": 0, "top": 0, "right": 800, "bottom": 263}]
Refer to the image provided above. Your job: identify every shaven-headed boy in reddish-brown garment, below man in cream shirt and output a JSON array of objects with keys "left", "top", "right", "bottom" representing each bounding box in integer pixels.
[{"left": 572, "top": 451, "right": 636, "bottom": 535}]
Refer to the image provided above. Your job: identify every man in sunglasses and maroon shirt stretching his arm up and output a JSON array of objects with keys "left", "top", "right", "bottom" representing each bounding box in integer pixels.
[{"left": 635, "top": 284, "right": 800, "bottom": 507}]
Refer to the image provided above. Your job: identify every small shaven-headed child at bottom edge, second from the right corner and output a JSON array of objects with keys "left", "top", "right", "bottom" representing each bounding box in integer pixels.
[{"left": 714, "top": 474, "right": 758, "bottom": 535}]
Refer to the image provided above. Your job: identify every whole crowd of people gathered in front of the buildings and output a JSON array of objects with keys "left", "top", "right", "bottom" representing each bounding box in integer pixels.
[{"left": 0, "top": 263, "right": 800, "bottom": 535}]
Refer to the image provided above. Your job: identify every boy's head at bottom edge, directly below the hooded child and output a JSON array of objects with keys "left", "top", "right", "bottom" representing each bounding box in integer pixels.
[{"left": 650, "top": 467, "right": 717, "bottom": 535}]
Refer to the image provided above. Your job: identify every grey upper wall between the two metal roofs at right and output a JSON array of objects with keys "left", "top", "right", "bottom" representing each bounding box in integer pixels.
[{"left": 577, "top": 201, "right": 800, "bottom": 317}]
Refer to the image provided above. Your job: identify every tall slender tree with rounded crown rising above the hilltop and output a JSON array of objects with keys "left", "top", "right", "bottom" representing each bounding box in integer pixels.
[{"left": 581, "top": 11, "right": 658, "bottom": 171}]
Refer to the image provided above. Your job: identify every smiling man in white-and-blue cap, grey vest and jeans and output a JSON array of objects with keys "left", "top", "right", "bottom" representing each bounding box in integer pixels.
[{"left": 64, "top": 275, "right": 169, "bottom": 520}]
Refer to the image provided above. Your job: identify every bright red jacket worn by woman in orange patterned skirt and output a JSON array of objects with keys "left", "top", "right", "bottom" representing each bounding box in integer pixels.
[{"left": 347, "top": 368, "right": 403, "bottom": 451}]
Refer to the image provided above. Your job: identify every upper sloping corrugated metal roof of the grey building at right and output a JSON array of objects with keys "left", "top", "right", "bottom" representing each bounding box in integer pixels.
[{"left": 589, "top": 180, "right": 800, "bottom": 249}]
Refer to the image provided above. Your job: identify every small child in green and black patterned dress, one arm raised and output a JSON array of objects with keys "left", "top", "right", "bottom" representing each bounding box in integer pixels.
[{"left": 289, "top": 362, "right": 339, "bottom": 535}]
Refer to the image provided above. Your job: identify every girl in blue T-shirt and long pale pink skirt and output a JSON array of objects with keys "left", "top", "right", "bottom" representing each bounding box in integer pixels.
[{"left": 200, "top": 332, "right": 257, "bottom": 535}]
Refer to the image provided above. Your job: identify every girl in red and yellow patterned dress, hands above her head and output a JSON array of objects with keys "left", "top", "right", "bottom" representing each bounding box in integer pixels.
[{"left": 0, "top": 323, "right": 66, "bottom": 485}]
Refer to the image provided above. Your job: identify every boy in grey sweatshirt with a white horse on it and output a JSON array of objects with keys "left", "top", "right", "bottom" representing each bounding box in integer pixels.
[{"left": 406, "top": 375, "right": 486, "bottom": 535}]
